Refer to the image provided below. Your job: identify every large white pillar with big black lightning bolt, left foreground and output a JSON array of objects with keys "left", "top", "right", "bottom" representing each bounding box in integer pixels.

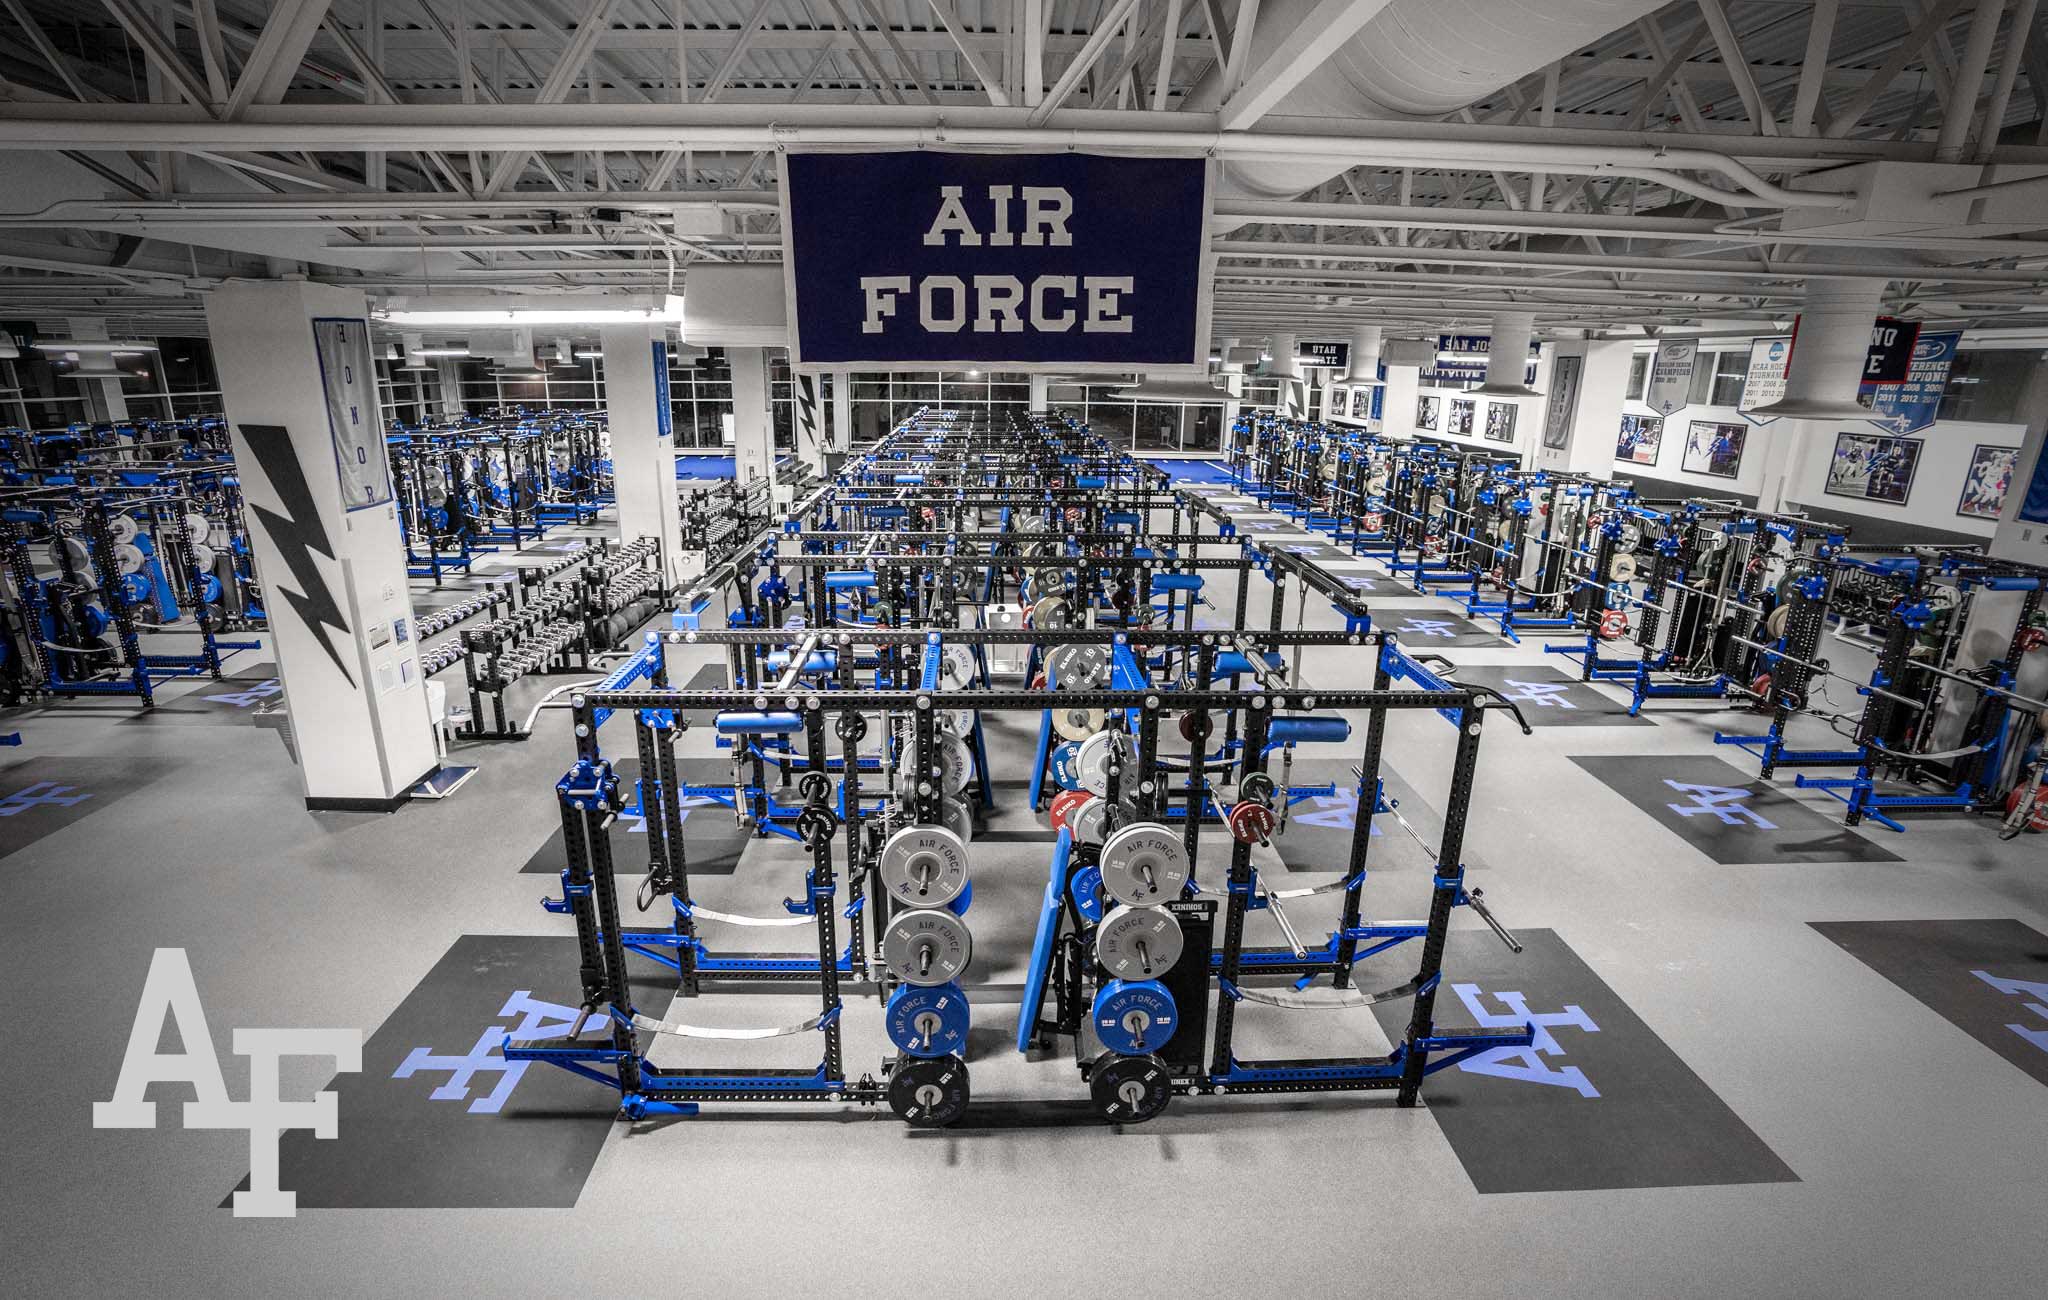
[{"left": 207, "top": 280, "right": 436, "bottom": 811}]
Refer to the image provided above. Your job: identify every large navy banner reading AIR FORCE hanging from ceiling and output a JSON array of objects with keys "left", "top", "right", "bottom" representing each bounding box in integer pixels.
[{"left": 782, "top": 149, "right": 1210, "bottom": 373}]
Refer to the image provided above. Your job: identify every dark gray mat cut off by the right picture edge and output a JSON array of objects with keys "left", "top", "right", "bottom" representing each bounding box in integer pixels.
[{"left": 1810, "top": 919, "right": 2048, "bottom": 1083}]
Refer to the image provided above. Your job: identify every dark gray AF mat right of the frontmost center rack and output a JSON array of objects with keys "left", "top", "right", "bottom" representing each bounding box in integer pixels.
[{"left": 1360, "top": 929, "right": 1798, "bottom": 1194}]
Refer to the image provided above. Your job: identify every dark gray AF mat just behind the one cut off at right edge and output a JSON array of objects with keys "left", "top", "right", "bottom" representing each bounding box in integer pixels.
[{"left": 1571, "top": 753, "right": 1901, "bottom": 866}]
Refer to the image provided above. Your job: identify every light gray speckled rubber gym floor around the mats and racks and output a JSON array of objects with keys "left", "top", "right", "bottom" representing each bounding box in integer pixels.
[{"left": 0, "top": 491, "right": 2048, "bottom": 1298}]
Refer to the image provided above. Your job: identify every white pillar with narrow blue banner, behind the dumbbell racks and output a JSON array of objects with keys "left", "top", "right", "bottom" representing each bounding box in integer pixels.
[{"left": 598, "top": 326, "right": 684, "bottom": 581}]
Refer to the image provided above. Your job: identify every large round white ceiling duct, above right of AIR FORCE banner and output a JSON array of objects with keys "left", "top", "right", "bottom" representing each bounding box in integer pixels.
[{"left": 1186, "top": 0, "right": 1663, "bottom": 199}]
